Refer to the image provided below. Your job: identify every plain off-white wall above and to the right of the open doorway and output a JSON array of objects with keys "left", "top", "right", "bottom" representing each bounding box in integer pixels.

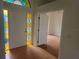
[{"left": 39, "top": 0, "right": 79, "bottom": 59}]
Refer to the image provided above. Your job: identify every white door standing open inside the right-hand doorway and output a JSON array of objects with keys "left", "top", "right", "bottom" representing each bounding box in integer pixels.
[{"left": 38, "top": 13, "right": 48, "bottom": 45}]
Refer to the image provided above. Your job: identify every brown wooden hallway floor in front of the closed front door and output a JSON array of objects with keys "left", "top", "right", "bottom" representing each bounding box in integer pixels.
[{"left": 6, "top": 35, "right": 58, "bottom": 59}]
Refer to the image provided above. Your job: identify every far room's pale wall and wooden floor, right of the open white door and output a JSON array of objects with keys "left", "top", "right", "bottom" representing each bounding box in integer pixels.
[{"left": 46, "top": 10, "right": 63, "bottom": 56}]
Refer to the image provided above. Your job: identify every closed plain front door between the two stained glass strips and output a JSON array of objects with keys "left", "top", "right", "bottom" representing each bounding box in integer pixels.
[{"left": 3, "top": 3, "right": 27, "bottom": 49}]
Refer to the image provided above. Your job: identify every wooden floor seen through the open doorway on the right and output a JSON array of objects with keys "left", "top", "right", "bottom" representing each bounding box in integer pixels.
[{"left": 39, "top": 35, "right": 60, "bottom": 58}]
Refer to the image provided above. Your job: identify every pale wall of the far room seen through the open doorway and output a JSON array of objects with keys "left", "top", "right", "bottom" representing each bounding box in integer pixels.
[{"left": 47, "top": 10, "right": 63, "bottom": 37}]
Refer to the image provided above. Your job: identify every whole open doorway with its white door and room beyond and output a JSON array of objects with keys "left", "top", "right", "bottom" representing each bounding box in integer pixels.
[{"left": 38, "top": 10, "right": 63, "bottom": 57}]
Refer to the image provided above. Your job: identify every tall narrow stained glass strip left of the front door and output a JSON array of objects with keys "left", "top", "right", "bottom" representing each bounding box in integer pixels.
[{"left": 3, "top": 10, "right": 10, "bottom": 50}]
